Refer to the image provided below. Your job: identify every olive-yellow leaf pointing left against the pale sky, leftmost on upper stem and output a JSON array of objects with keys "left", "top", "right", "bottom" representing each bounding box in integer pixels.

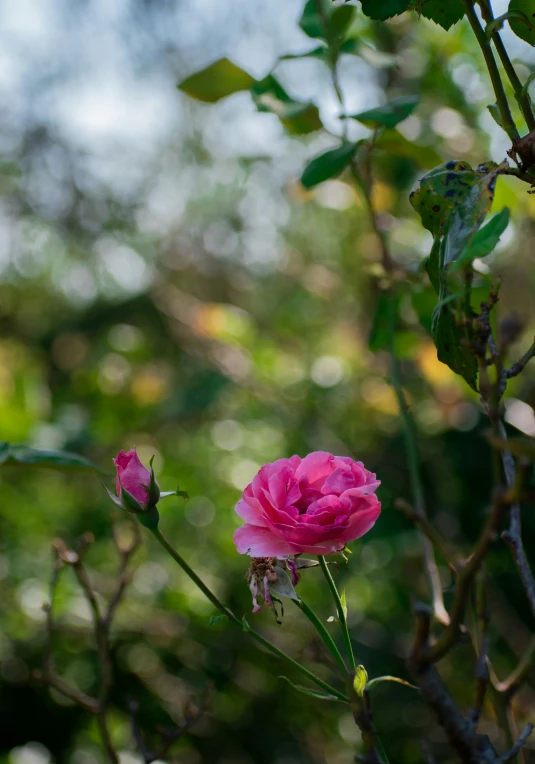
[{"left": 178, "top": 58, "right": 256, "bottom": 103}]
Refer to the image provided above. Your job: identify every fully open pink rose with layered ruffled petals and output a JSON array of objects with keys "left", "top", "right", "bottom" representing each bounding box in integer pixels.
[{"left": 234, "top": 451, "right": 381, "bottom": 557}]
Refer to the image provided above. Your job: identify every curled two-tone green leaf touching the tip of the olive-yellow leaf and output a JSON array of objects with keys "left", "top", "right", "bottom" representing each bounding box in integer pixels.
[{"left": 251, "top": 74, "right": 323, "bottom": 135}]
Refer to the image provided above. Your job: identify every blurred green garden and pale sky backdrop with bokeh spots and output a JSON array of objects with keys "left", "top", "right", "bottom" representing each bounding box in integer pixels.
[{"left": 0, "top": 0, "right": 535, "bottom": 764}]
